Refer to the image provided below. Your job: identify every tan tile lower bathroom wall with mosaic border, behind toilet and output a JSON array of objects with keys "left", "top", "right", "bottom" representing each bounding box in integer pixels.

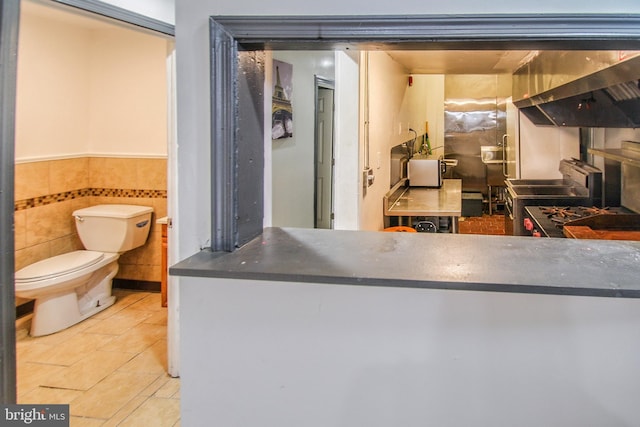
[{"left": 15, "top": 157, "right": 167, "bottom": 304}]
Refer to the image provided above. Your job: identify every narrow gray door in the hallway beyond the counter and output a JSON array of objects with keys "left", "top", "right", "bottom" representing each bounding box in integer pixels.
[{"left": 314, "top": 76, "right": 335, "bottom": 229}]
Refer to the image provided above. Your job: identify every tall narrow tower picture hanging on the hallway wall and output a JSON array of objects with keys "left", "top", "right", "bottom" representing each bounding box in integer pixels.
[{"left": 271, "top": 60, "right": 293, "bottom": 139}]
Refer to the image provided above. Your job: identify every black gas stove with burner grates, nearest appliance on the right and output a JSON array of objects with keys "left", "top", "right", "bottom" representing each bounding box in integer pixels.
[{"left": 523, "top": 206, "right": 634, "bottom": 237}]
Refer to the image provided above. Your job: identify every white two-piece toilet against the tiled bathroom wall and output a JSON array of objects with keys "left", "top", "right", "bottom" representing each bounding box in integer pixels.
[{"left": 15, "top": 204, "right": 153, "bottom": 337}]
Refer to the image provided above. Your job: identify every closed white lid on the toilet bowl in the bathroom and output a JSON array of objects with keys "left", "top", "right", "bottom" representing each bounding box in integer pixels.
[{"left": 15, "top": 251, "right": 104, "bottom": 282}]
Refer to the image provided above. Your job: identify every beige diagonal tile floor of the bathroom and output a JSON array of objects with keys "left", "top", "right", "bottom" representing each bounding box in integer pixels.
[{"left": 16, "top": 289, "right": 180, "bottom": 427}]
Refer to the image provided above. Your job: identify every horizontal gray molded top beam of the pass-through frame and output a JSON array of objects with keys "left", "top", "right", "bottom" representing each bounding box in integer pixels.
[{"left": 213, "top": 14, "right": 640, "bottom": 50}]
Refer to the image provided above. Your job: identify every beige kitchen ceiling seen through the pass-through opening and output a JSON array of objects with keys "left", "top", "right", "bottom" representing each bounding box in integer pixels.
[{"left": 387, "top": 50, "right": 536, "bottom": 74}]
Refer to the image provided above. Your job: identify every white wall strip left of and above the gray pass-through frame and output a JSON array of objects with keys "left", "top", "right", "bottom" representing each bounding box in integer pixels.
[{"left": 176, "top": 0, "right": 640, "bottom": 258}]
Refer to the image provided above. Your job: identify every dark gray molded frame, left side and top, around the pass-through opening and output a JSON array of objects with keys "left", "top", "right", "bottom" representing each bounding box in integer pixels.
[{"left": 209, "top": 14, "right": 640, "bottom": 252}]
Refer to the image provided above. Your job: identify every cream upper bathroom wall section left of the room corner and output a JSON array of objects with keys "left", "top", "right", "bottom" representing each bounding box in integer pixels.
[{"left": 15, "top": 7, "right": 91, "bottom": 161}]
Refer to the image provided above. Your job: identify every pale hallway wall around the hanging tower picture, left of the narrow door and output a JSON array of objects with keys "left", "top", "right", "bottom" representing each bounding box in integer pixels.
[{"left": 266, "top": 51, "right": 335, "bottom": 228}]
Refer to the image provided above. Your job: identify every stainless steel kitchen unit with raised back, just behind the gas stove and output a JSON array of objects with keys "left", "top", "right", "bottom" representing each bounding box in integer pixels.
[{"left": 504, "top": 159, "right": 602, "bottom": 236}]
